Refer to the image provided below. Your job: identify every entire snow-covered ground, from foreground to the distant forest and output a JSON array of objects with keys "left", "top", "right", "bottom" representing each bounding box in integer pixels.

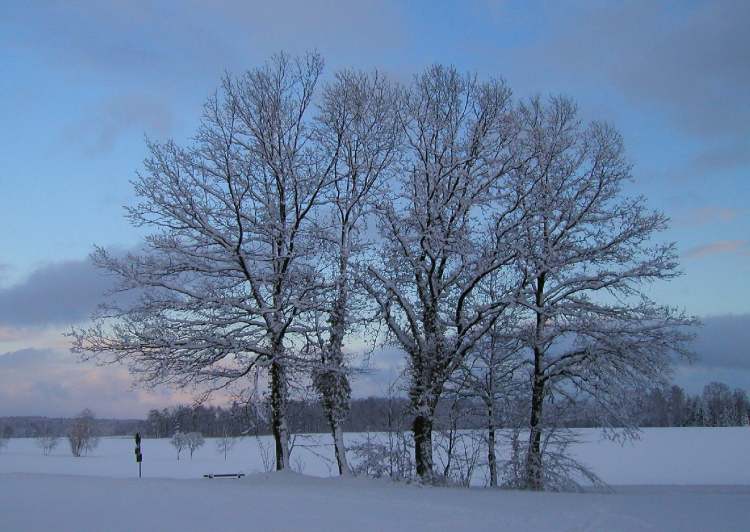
[{"left": 0, "top": 427, "right": 750, "bottom": 532}]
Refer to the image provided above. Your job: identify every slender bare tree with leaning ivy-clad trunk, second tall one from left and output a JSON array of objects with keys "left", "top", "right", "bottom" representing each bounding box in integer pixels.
[{"left": 313, "top": 71, "right": 398, "bottom": 475}]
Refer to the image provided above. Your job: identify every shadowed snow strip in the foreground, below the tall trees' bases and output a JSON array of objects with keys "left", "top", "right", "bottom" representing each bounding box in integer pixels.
[{"left": 0, "top": 473, "right": 750, "bottom": 532}]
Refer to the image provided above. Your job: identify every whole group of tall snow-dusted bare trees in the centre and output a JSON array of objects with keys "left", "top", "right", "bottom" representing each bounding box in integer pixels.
[{"left": 73, "top": 53, "right": 692, "bottom": 489}]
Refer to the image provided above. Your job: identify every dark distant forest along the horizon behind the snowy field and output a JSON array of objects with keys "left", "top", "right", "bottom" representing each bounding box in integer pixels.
[{"left": 0, "top": 382, "right": 750, "bottom": 438}]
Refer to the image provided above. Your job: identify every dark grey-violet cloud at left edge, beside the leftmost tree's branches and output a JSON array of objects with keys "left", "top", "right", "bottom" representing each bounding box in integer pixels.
[{"left": 0, "top": 259, "right": 111, "bottom": 327}]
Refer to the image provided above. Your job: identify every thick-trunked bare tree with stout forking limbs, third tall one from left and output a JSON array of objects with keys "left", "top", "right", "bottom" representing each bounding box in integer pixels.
[{"left": 365, "top": 66, "right": 518, "bottom": 481}]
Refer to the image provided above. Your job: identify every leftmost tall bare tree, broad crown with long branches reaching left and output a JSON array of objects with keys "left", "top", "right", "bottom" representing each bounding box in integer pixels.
[{"left": 73, "top": 54, "right": 335, "bottom": 469}]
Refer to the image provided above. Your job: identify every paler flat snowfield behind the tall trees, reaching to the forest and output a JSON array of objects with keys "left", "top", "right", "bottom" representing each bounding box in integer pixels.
[{"left": 0, "top": 427, "right": 750, "bottom": 486}]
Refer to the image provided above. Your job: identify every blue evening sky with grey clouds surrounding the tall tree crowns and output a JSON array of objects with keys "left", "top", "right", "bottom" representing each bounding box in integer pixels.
[{"left": 0, "top": 0, "right": 750, "bottom": 415}]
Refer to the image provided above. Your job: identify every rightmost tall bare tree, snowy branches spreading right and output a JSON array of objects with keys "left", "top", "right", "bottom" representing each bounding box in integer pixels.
[{"left": 514, "top": 97, "right": 693, "bottom": 489}]
